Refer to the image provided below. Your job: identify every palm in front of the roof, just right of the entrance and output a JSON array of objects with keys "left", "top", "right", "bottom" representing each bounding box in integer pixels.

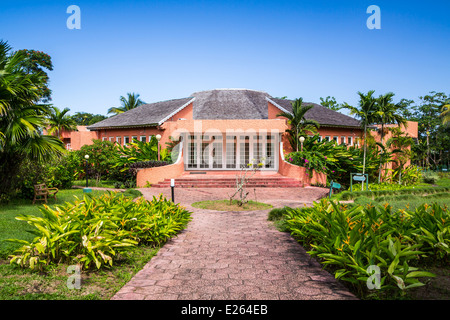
[{"left": 277, "top": 98, "right": 319, "bottom": 152}]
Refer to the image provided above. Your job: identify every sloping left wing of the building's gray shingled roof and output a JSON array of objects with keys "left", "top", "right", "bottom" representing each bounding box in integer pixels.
[{"left": 88, "top": 97, "right": 193, "bottom": 130}]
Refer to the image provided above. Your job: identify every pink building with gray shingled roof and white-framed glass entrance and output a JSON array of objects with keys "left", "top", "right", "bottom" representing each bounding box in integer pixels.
[{"left": 85, "top": 89, "right": 361, "bottom": 186}]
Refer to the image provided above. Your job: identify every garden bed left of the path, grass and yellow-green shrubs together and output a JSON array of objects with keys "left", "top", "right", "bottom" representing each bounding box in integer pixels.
[{"left": 0, "top": 190, "right": 190, "bottom": 300}]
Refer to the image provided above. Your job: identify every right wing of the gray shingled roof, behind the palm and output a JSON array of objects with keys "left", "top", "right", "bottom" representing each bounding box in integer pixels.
[{"left": 270, "top": 98, "right": 361, "bottom": 128}]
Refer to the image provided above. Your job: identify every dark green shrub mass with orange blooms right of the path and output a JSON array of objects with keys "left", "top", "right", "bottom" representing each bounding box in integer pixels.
[{"left": 285, "top": 199, "right": 450, "bottom": 296}]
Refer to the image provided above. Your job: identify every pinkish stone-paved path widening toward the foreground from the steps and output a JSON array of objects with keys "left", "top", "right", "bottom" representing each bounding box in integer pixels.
[{"left": 113, "top": 188, "right": 355, "bottom": 300}]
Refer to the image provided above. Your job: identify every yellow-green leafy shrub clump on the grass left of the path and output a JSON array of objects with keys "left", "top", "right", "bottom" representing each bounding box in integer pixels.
[{"left": 6, "top": 192, "right": 190, "bottom": 270}]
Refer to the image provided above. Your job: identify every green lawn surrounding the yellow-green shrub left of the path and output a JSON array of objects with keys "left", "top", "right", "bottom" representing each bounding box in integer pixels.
[{"left": 0, "top": 189, "right": 171, "bottom": 300}]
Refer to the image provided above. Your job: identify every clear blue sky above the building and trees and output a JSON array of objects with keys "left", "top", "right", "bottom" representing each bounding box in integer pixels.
[{"left": 0, "top": 0, "right": 450, "bottom": 114}]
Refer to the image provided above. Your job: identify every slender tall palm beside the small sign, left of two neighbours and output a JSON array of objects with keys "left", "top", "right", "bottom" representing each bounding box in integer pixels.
[{"left": 343, "top": 90, "right": 377, "bottom": 174}]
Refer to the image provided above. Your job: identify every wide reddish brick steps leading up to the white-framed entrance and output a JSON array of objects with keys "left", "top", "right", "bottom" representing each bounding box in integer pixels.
[{"left": 152, "top": 173, "right": 303, "bottom": 188}]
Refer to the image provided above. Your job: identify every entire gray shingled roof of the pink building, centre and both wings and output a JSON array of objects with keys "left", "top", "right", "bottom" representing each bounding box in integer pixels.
[{"left": 88, "top": 89, "right": 360, "bottom": 130}]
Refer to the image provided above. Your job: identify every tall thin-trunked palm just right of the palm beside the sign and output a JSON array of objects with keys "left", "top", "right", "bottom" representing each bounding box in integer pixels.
[{"left": 375, "top": 92, "right": 407, "bottom": 183}]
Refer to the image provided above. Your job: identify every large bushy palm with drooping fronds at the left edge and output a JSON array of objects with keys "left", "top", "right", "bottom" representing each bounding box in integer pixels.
[{"left": 0, "top": 41, "right": 64, "bottom": 194}]
